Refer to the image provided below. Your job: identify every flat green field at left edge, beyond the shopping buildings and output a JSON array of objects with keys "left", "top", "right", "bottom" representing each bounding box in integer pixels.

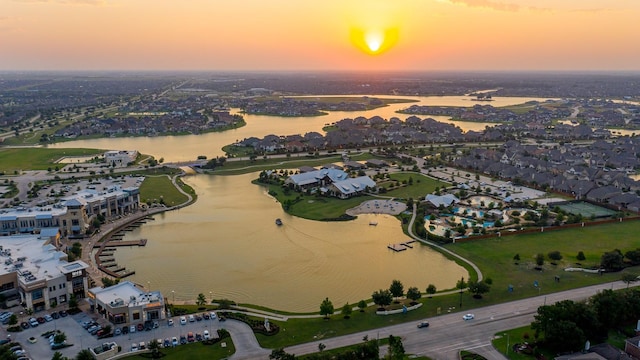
[{"left": 0, "top": 148, "right": 104, "bottom": 174}]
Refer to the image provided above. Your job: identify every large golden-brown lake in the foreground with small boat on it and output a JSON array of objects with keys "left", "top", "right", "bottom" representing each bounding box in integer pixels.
[{"left": 115, "top": 173, "right": 468, "bottom": 311}]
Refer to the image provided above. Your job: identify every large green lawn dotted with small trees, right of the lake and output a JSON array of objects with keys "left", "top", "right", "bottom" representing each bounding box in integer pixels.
[{"left": 447, "top": 221, "right": 640, "bottom": 301}]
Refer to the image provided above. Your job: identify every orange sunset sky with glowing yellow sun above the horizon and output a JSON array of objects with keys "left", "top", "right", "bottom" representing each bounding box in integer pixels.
[{"left": 0, "top": 0, "right": 640, "bottom": 71}]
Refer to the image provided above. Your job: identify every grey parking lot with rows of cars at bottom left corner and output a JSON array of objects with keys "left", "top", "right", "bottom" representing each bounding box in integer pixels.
[{"left": 3, "top": 313, "right": 226, "bottom": 359}]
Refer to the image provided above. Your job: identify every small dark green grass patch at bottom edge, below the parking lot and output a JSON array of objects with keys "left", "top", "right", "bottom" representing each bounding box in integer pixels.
[{"left": 122, "top": 338, "right": 236, "bottom": 360}]
